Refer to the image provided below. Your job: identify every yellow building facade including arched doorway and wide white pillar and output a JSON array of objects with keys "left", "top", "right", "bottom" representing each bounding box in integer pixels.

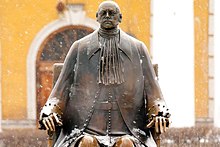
[{"left": 0, "top": 0, "right": 217, "bottom": 128}]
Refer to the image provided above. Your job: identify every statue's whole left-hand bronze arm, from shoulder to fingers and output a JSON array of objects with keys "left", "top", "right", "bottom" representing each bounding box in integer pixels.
[{"left": 39, "top": 42, "right": 78, "bottom": 131}]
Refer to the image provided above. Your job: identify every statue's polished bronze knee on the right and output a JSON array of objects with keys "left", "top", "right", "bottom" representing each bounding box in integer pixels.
[{"left": 114, "top": 136, "right": 134, "bottom": 147}]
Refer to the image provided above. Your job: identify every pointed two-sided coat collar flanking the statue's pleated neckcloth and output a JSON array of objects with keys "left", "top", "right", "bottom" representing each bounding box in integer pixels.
[{"left": 87, "top": 29, "right": 132, "bottom": 60}]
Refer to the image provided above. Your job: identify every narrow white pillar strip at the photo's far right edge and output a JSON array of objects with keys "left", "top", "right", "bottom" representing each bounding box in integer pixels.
[{"left": 214, "top": 0, "right": 220, "bottom": 127}]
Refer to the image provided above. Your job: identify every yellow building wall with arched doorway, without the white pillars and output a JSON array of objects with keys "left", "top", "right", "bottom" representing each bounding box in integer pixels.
[{"left": 0, "top": 0, "right": 213, "bottom": 127}]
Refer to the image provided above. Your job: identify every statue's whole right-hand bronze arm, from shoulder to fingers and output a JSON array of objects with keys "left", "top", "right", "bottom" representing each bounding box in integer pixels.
[{"left": 138, "top": 43, "right": 170, "bottom": 134}]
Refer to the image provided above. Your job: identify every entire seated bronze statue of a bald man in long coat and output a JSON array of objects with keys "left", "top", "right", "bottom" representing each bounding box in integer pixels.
[{"left": 39, "top": 1, "right": 170, "bottom": 147}]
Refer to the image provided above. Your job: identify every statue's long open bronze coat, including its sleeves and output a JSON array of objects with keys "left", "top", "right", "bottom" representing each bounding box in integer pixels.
[{"left": 43, "top": 30, "right": 163, "bottom": 145}]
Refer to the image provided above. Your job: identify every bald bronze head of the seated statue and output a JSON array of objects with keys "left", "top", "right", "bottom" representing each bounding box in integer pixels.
[{"left": 96, "top": 1, "right": 121, "bottom": 30}]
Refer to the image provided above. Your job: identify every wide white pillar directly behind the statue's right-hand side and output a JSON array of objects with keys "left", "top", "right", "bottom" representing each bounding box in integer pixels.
[{"left": 151, "top": 0, "right": 195, "bottom": 127}]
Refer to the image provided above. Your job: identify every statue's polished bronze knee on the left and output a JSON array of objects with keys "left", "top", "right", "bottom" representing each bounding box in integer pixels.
[{"left": 79, "top": 136, "right": 99, "bottom": 147}]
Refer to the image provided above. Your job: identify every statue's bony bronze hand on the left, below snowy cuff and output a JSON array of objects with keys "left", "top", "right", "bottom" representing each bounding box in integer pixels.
[{"left": 41, "top": 113, "right": 63, "bottom": 132}]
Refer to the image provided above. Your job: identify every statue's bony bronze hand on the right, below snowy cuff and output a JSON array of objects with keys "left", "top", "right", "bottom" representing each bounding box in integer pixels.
[{"left": 147, "top": 115, "right": 171, "bottom": 134}]
